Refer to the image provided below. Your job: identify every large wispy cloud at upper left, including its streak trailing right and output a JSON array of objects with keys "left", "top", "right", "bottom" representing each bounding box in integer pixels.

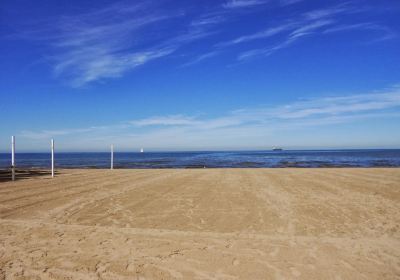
[{"left": 22, "top": 2, "right": 223, "bottom": 87}]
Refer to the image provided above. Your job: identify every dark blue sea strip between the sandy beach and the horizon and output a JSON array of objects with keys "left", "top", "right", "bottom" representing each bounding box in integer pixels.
[{"left": 0, "top": 150, "right": 400, "bottom": 168}]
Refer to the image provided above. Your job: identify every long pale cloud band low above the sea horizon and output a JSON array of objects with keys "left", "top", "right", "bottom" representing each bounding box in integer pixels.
[{"left": 19, "top": 87, "right": 400, "bottom": 149}]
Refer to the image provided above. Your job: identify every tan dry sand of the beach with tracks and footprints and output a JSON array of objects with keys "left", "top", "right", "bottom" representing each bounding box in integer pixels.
[{"left": 0, "top": 168, "right": 400, "bottom": 279}]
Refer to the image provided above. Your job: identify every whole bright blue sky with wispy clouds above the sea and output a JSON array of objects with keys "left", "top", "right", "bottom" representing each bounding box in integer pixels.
[{"left": 0, "top": 0, "right": 400, "bottom": 152}]
